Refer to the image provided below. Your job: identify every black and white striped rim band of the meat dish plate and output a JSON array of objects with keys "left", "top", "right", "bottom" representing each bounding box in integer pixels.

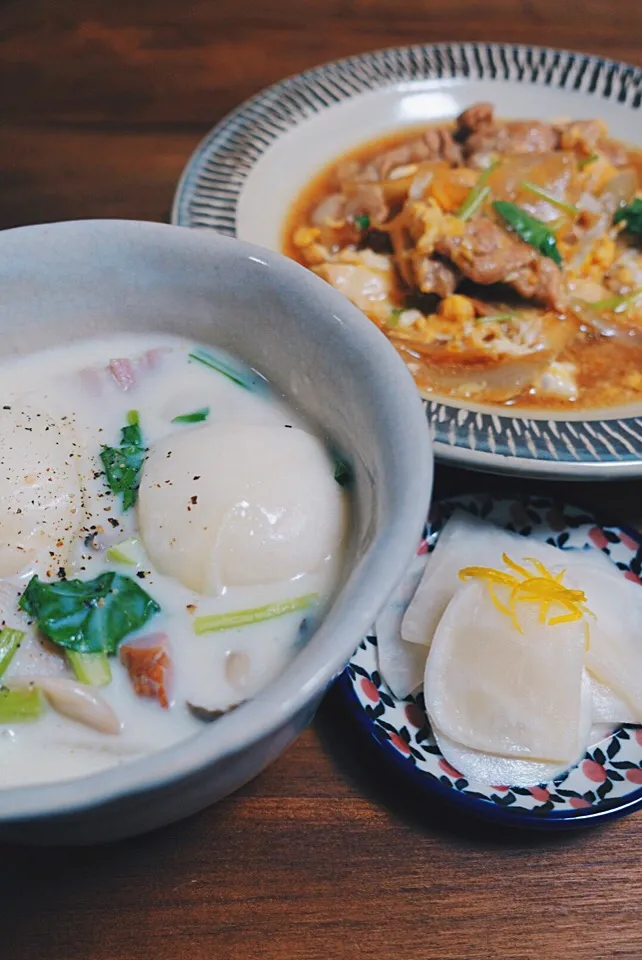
[{"left": 172, "top": 43, "right": 642, "bottom": 477}]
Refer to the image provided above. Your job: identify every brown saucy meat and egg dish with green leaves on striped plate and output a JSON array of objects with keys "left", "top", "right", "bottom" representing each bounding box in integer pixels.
[{"left": 284, "top": 103, "right": 642, "bottom": 409}]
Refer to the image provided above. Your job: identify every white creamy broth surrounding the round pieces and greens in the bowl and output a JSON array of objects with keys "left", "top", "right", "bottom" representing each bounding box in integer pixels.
[{"left": 0, "top": 335, "right": 346, "bottom": 786}]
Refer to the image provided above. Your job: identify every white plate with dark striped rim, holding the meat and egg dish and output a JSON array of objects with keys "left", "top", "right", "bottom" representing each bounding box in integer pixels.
[{"left": 172, "top": 43, "right": 642, "bottom": 479}]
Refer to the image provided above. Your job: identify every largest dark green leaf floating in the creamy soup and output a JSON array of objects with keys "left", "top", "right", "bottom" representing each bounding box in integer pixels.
[{"left": 19, "top": 572, "right": 160, "bottom": 656}]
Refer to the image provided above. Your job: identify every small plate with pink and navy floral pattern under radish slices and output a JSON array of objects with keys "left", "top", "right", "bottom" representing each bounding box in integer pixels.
[{"left": 337, "top": 496, "right": 642, "bottom": 829}]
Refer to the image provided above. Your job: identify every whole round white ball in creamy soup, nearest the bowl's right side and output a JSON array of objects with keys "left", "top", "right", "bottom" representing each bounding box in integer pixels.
[{"left": 139, "top": 423, "right": 346, "bottom": 594}]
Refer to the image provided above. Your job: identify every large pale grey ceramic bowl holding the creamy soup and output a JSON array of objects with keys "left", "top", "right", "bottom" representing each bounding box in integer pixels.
[{"left": 0, "top": 221, "right": 432, "bottom": 843}]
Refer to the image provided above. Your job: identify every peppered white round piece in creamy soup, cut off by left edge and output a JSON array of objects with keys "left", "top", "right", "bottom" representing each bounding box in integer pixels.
[{"left": 0, "top": 406, "right": 83, "bottom": 577}]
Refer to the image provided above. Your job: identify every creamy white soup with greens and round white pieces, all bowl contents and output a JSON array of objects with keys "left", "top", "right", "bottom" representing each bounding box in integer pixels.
[{"left": 0, "top": 336, "right": 348, "bottom": 786}]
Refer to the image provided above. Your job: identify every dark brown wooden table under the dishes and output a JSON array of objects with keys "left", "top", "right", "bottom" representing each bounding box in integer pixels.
[{"left": 0, "top": 0, "right": 642, "bottom": 960}]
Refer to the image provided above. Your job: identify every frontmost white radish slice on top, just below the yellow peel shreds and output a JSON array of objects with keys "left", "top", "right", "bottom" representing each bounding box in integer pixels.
[{"left": 424, "top": 580, "right": 585, "bottom": 763}]
